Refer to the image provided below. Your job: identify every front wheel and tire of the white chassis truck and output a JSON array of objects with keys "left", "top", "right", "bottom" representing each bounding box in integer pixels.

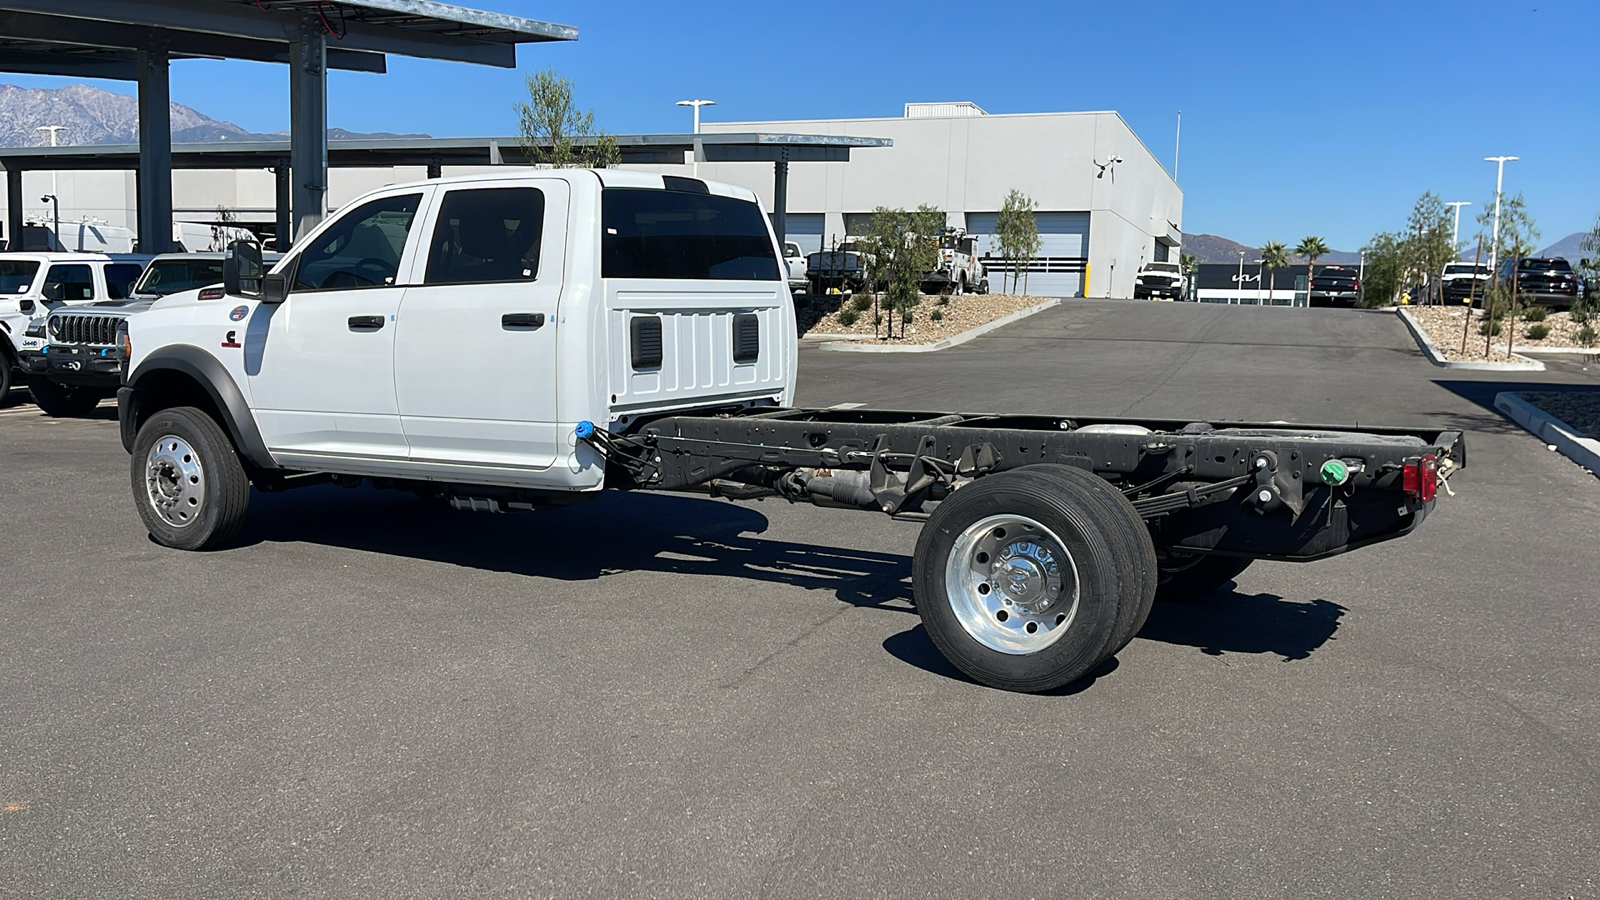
[{"left": 130, "top": 407, "right": 250, "bottom": 549}]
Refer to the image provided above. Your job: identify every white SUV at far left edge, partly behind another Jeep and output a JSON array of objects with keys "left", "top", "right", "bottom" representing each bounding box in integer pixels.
[{"left": 0, "top": 251, "right": 149, "bottom": 400}]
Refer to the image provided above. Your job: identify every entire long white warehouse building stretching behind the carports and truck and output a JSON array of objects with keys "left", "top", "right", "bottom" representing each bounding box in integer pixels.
[{"left": 0, "top": 102, "right": 1182, "bottom": 296}]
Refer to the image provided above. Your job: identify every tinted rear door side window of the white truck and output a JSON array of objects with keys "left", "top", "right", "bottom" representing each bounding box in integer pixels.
[{"left": 422, "top": 187, "right": 544, "bottom": 285}]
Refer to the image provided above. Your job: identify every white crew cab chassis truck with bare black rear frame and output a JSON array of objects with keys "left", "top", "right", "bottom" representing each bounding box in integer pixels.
[{"left": 117, "top": 170, "right": 1464, "bottom": 690}]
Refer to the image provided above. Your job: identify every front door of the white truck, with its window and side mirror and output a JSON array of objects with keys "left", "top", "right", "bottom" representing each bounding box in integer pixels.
[{"left": 244, "top": 189, "right": 432, "bottom": 461}]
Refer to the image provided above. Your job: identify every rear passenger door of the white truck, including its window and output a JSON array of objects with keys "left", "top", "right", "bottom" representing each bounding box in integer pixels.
[{"left": 395, "top": 179, "right": 568, "bottom": 471}]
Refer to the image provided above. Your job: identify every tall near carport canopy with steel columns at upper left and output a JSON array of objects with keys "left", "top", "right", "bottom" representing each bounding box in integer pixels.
[{"left": 0, "top": 0, "right": 578, "bottom": 251}]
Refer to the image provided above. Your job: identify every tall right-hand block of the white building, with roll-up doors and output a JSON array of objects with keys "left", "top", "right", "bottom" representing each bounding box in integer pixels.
[{"left": 699, "top": 102, "right": 1182, "bottom": 296}]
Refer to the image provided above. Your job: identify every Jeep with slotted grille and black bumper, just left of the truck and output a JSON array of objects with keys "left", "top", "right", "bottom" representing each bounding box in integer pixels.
[{"left": 18, "top": 253, "right": 282, "bottom": 416}]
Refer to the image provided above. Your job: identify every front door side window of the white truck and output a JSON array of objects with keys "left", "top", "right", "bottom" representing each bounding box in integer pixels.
[{"left": 293, "top": 194, "right": 422, "bottom": 291}]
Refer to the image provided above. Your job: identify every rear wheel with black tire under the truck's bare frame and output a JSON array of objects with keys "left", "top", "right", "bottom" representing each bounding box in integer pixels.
[{"left": 912, "top": 469, "right": 1138, "bottom": 692}]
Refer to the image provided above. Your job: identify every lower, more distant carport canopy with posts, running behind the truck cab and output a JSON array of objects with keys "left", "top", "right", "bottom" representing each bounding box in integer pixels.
[{"left": 0, "top": 129, "right": 894, "bottom": 250}]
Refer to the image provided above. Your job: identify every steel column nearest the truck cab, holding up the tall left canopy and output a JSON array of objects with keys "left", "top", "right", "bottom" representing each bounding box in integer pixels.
[{"left": 290, "top": 16, "right": 328, "bottom": 240}]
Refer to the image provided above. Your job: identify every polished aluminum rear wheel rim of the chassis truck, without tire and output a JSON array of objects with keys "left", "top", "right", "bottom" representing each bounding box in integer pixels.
[{"left": 944, "top": 516, "right": 1078, "bottom": 655}]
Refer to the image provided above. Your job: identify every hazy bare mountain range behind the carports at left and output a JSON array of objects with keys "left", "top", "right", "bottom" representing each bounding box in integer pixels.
[{"left": 0, "top": 85, "right": 427, "bottom": 147}]
